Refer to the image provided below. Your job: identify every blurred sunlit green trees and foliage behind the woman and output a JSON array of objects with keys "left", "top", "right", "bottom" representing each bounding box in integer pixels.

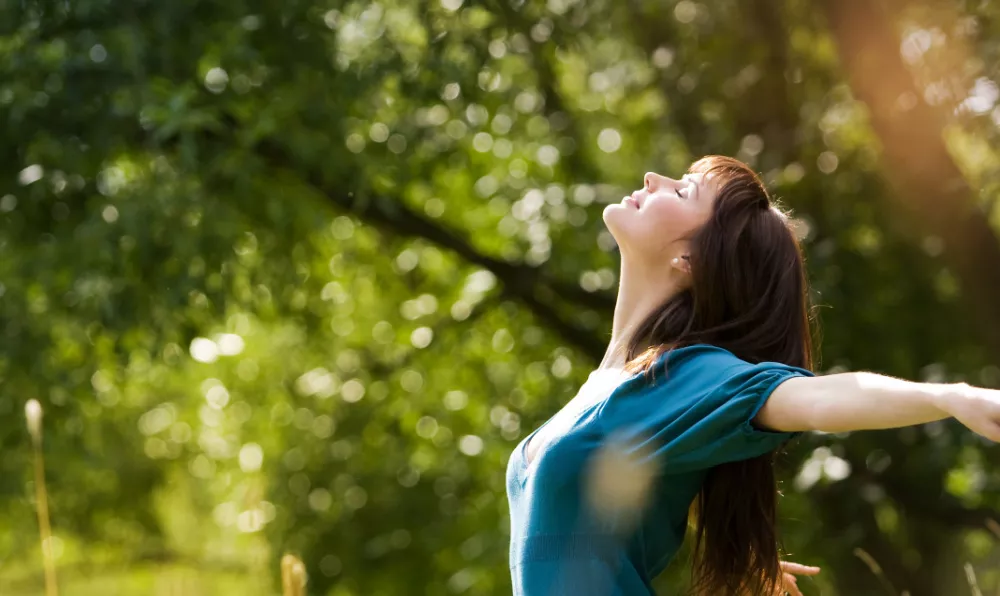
[{"left": 0, "top": 0, "right": 1000, "bottom": 596}]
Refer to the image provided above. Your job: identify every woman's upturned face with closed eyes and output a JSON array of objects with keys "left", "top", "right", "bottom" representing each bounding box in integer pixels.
[{"left": 603, "top": 172, "right": 715, "bottom": 263}]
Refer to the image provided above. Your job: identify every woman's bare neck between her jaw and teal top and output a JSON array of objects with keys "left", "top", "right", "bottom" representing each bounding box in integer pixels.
[{"left": 598, "top": 256, "right": 680, "bottom": 368}]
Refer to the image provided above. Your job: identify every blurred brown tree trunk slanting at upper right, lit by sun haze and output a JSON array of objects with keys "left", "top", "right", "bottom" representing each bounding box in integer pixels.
[{"left": 823, "top": 0, "right": 1000, "bottom": 361}]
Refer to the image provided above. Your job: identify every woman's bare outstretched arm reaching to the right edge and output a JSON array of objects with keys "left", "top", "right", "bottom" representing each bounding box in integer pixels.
[{"left": 754, "top": 372, "right": 1000, "bottom": 441}]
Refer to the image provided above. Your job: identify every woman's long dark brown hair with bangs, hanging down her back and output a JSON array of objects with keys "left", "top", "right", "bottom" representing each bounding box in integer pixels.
[{"left": 625, "top": 155, "right": 813, "bottom": 596}]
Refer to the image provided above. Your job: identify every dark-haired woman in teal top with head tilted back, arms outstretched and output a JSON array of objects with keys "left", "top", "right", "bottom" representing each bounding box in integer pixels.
[{"left": 507, "top": 156, "right": 1000, "bottom": 596}]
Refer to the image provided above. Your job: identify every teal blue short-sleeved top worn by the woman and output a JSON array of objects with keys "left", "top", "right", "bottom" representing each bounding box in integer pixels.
[{"left": 507, "top": 345, "right": 812, "bottom": 596}]
